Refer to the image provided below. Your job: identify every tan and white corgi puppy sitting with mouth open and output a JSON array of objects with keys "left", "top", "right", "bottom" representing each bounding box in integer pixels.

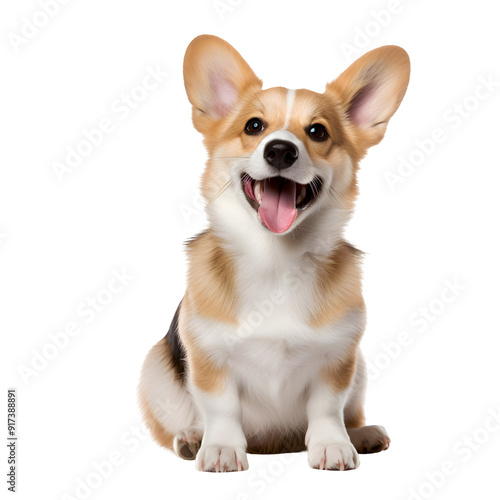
[{"left": 139, "top": 35, "right": 410, "bottom": 472}]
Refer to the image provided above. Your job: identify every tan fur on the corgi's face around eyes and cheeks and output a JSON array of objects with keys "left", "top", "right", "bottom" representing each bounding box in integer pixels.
[{"left": 201, "top": 82, "right": 366, "bottom": 209}]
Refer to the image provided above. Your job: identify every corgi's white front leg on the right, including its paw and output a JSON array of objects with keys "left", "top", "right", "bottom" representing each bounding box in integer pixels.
[{"left": 306, "top": 380, "right": 359, "bottom": 470}]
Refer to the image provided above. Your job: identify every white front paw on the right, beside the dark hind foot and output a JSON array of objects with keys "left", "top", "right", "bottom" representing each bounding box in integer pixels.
[{"left": 308, "top": 442, "right": 359, "bottom": 470}]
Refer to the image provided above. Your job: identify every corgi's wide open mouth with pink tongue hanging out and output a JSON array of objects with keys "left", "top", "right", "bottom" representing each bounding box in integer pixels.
[{"left": 241, "top": 174, "right": 323, "bottom": 233}]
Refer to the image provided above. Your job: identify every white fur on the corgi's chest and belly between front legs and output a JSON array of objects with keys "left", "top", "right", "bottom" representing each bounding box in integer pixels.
[{"left": 186, "top": 252, "right": 364, "bottom": 433}]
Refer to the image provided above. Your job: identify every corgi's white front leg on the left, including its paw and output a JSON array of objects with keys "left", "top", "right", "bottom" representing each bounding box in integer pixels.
[{"left": 191, "top": 377, "right": 248, "bottom": 472}]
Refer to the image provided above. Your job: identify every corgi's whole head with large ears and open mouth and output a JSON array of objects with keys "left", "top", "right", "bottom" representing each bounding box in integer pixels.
[{"left": 184, "top": 35, "right": 410, "bottom": 234}]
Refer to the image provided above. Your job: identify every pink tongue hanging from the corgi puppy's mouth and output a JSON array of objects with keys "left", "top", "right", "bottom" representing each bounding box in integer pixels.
[{"left": 259, "top": 177, "right": 297, "bottom": 233}]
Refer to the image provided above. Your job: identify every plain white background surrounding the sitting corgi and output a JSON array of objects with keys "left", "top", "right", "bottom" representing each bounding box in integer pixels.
[{"left": 0, "top": 0, "right": 500, "bottom": 500}]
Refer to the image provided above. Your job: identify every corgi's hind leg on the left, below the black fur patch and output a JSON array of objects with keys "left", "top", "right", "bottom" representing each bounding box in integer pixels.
[{"left": 139, "top": 339, "right": 202, "bottom": 460}]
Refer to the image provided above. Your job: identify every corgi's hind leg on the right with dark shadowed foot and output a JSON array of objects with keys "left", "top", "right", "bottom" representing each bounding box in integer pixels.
[{"left": 344, "top": 351, "right": 391, "bottom": 454}]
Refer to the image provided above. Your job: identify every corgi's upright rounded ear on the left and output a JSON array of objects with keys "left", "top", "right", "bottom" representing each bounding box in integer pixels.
[{"left": 184, "top": 35, "right": 262, "bottom": 132}]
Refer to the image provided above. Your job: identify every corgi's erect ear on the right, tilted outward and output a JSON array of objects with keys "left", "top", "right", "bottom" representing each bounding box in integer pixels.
[{"left": 326, "top": 45, "right": 410, "bottom": 147}]
